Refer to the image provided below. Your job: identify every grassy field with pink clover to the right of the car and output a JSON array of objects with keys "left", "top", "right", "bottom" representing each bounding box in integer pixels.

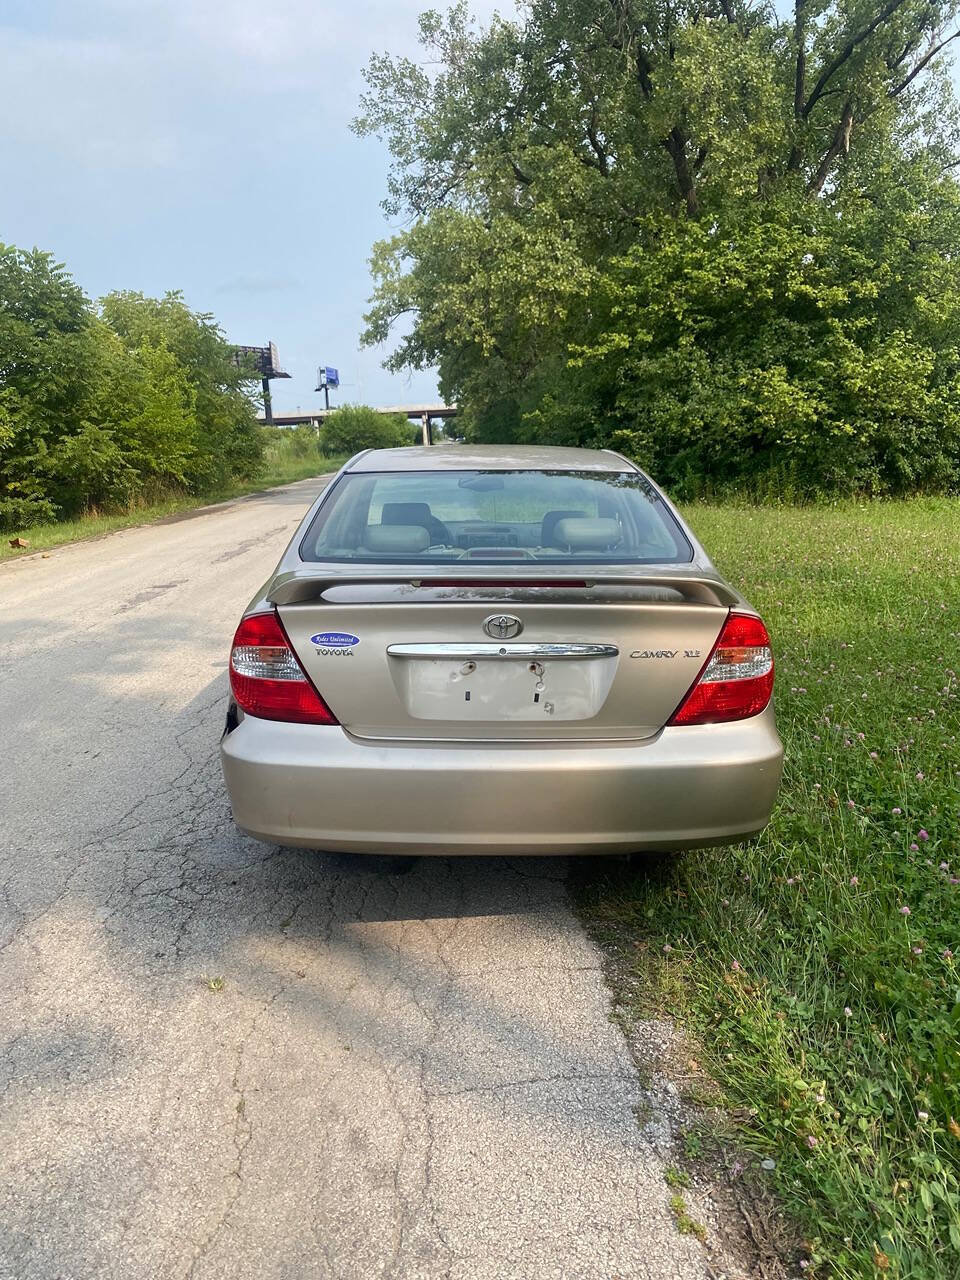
[{"left": 576, "top": 499, "right": 960, "bottom": 1280}]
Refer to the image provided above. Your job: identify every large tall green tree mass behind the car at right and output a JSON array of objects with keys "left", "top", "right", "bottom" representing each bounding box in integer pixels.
[{"left": 356, "top": 0, "right": 957, "bottom": 490}]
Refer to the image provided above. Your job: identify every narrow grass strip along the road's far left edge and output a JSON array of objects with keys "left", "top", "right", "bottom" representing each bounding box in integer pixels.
[{"left": 0, "top": 456, "right": 347, "bottom": 559}]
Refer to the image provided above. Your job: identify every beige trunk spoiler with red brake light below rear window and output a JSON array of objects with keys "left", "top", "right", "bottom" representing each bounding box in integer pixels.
[{"left": 266, "top": 563, "right": 745, "bottom": 608}]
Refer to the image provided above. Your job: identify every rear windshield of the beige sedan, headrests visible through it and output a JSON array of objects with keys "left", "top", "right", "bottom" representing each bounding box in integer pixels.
[{"left": 300, "top": 471, "right": 692, "bottom": 564}]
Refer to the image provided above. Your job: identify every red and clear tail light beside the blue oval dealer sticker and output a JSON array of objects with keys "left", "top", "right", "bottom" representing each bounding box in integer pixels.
[{"left": 230, "top": 612, "right": 339, "bottom": 724}]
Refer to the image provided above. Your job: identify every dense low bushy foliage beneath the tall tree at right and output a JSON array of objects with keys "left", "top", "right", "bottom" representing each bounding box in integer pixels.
[{"left": 583, "top": 175, "right": 960, "bottom": 497}]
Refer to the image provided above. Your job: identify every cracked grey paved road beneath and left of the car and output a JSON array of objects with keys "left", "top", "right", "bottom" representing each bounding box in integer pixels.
[{"left": 0, "top": 481, "right": 747, "bottom": 1280}]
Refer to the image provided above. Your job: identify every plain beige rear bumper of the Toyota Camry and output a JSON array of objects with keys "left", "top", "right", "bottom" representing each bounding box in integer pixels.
[{"left": 221, "top": 707, "right": 783, "bottom": 854}]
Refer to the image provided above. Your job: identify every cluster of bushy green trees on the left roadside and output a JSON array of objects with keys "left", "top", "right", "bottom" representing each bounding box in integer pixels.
[{"left": 0, "top": 244, "right": 261, "bottom": 529}]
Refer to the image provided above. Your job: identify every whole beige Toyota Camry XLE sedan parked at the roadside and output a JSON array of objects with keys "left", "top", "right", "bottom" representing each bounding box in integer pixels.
[{"left": 221, "top": 445, "right": 782, "bottom": 854}]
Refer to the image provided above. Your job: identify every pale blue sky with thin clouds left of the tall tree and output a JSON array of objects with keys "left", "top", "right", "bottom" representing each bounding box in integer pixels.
[{"left": 0, "top": 0, "right": 512, "bottom": 412}]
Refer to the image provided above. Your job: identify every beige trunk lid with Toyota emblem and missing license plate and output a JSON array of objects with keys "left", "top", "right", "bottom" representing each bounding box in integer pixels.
[{"left": 270, "top": 571, "right": 733, "bottom": 741}]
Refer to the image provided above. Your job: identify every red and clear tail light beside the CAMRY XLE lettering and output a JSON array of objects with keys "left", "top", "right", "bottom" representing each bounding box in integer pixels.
[{"left": 668, "top": 613, "right": 773, "bottom": 724}]
